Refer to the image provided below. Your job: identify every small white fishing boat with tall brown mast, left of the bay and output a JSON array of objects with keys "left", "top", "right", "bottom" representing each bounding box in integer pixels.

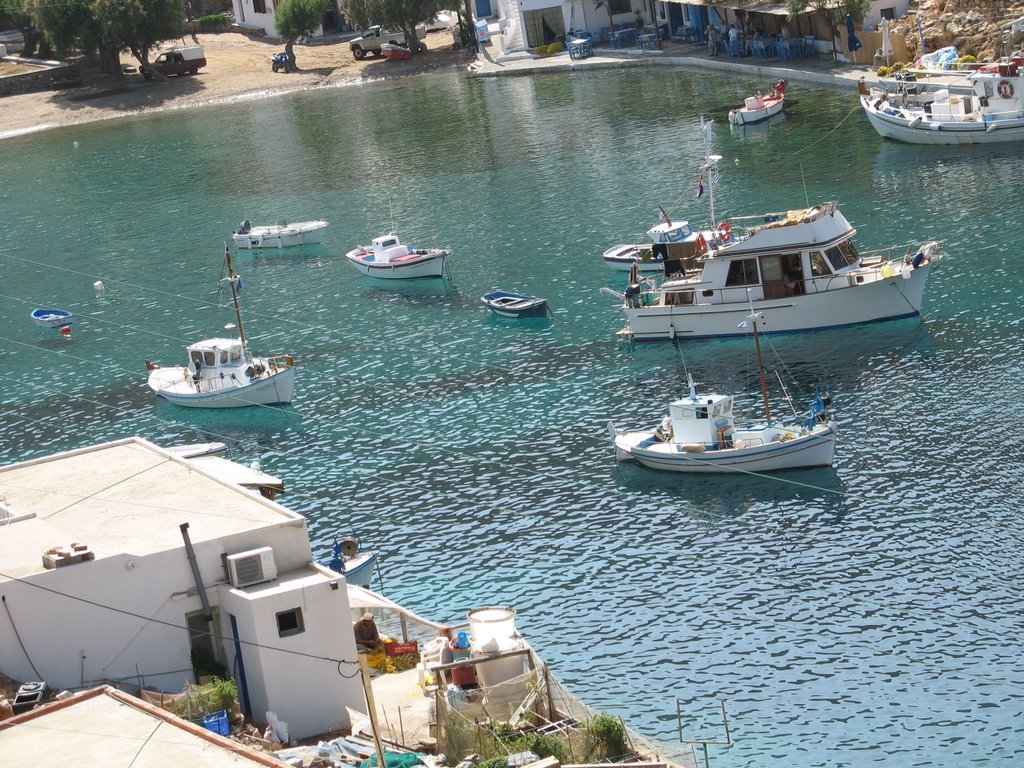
[{"left": 145, "top": 248, "right": 295, "bottom": 409}]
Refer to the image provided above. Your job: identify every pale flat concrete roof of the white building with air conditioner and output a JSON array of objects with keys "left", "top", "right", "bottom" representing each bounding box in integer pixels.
[{"left": 0, "top": 437, "right": 304, "bottom": 583}]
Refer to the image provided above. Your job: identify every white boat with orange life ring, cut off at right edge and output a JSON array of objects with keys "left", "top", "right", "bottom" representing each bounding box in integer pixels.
[{"left": 858, "top": 55, "right": 1024, "bottom": 144}]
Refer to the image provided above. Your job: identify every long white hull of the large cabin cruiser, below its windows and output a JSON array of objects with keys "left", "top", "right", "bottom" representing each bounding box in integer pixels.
[{"left": 620, "top": 262, "right": 936, "bottom": 341}]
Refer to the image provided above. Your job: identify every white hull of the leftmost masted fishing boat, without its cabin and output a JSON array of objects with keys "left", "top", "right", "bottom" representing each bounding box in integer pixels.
[{"left": 148, "top": 366, "right": 295, "bottom": 409}]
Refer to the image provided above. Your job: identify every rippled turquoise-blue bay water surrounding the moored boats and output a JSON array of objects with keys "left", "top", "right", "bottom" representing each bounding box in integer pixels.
[{"left": 0, "top": 70, "right": 1024, "bottom": 768}]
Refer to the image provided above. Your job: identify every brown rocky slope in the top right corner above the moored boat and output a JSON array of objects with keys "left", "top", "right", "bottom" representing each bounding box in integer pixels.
[{"left": 892, "top": 0, "right": 1024, "bottom": 60}]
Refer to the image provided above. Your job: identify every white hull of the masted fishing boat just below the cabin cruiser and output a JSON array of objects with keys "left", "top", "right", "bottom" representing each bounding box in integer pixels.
[{"left": 614, "top": 427, "right": 836, "bottom": 474}]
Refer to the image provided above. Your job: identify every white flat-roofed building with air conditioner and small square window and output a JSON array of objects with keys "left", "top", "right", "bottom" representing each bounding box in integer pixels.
[{"left": 0, "top": 437, "right": 365, "bottom": 738}]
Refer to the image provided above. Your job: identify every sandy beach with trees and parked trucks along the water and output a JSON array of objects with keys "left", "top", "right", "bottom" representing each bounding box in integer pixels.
[{"left": 0, "top": 30, "right": 474, "bottom": 138}]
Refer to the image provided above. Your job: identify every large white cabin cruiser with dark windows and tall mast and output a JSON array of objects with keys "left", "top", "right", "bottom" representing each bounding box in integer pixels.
[{"left": 604, "top": 116, "right": 944, "bottom": 341}]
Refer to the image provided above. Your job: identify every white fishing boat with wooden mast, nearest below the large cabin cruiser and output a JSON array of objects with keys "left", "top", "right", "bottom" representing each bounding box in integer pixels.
[{"left": 608, "top": 313, "right": 836, "bottom": 473}]
